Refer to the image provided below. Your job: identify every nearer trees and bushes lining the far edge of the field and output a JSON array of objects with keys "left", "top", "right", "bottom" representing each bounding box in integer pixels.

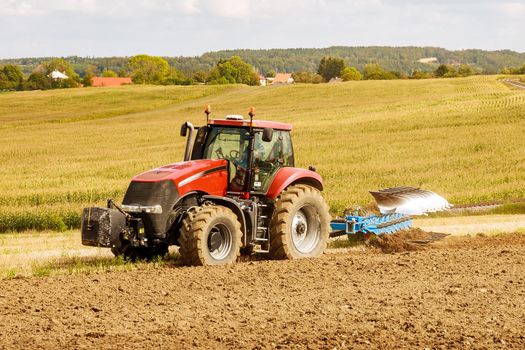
[{"left": 0, "top": 55, "right": 525, "bottom": 91}]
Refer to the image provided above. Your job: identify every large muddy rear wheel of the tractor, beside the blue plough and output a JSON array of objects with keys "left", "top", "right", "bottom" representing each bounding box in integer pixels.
[{"left": 270, "top": 185, "right": 330, "bottom": 259}]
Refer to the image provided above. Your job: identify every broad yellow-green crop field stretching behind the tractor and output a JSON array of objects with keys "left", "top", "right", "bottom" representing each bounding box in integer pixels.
[{"left": 0, "top": 76, "right": 525, "bottom": 232}]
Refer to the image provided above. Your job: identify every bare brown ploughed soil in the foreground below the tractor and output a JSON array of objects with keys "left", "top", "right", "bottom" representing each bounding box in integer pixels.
[{"left": 0, "top": 234, "right": 525, "bottom": 349}]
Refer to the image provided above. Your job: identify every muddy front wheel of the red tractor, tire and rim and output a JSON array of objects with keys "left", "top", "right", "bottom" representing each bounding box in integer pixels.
[{"left": 179, "top": 205, "right": 242, "bottom": 266}]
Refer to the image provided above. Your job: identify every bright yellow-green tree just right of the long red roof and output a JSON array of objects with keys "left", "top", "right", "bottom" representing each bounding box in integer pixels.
[{"left": 128, "top": 55, "right": 169, "bottom": 84}]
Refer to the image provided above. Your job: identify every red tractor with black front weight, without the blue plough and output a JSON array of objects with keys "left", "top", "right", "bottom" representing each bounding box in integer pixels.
[{"left": 82, "top": 106, "right": 330, "bottom": 265}]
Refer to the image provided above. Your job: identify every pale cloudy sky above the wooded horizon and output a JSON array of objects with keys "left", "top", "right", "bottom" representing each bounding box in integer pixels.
[{"left": 0, "top": 0, "right": 525, "bottom": 58}]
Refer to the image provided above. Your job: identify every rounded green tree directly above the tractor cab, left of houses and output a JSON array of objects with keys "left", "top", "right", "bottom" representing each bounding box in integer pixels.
[{"left": 209, "top": 56, "right": 259, "bottom": 85}]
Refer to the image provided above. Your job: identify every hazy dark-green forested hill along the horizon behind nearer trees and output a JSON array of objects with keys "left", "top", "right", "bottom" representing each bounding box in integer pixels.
[{"left": 0, "top": 46, "right": 525, "bottom": 77}]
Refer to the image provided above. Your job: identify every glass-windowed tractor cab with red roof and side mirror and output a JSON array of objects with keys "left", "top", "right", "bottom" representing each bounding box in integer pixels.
[{"left": 181, "top": 111, "right": 294, "bottom": 194}]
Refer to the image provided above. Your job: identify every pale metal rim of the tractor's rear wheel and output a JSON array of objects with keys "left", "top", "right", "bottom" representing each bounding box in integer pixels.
[{"left": 292, "top": 206, "right": 321, "bottom": 254}]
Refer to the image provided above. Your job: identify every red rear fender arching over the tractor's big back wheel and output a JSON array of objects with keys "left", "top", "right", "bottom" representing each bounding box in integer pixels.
[{"left": 266, "top": 167, "right": 323, "bottom": 199}]
